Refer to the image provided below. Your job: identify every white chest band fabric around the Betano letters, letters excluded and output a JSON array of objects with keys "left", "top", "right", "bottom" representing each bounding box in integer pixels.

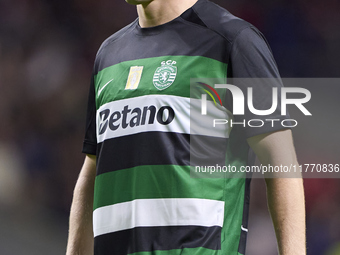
[{"left": 97, "top": 95, "right": 230, "bottom": 143}]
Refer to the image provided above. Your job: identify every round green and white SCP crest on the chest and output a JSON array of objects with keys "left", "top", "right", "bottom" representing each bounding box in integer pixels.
[{"left": 153, "top": 60, "right": 177, "bottom": 90}]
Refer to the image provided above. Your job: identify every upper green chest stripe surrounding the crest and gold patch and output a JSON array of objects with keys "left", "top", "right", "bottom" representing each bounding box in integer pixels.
[{"left": 95, "top": 56, "right": 227, "bottom": 109}]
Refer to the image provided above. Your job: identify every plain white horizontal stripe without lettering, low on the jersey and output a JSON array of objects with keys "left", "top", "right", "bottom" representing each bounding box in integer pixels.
[{"left": 93, "top": 198, "right": 224, "bottom": 236}]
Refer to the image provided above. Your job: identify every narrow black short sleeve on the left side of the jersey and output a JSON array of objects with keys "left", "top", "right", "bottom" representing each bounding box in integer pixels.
[{"left": 82, "top": 74, "right": 97, "bottom": 155}]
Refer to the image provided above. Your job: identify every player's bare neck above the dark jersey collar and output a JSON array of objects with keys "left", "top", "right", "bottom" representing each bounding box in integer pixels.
[{"left": 137, "top": 0, "right": 197, "bottom": 27}]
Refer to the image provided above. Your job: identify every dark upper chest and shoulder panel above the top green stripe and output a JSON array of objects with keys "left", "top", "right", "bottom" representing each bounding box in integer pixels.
[{"left": 95, "top": 0, "right": 255, "bottom": 74}]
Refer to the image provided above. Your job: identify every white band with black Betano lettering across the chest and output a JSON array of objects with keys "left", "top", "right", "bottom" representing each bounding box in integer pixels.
[{"left": 97, "top": 95, "right": 230, "bottom": 143}]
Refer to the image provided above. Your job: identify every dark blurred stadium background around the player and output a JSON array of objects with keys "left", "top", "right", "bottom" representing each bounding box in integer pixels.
[{"left": 0, "top": 0, "right": 340, "bottom": 255}]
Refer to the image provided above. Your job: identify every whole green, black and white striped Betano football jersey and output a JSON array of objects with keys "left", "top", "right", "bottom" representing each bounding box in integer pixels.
[{"left": 83, "top": 0, "right": 285, "bottom": 255}]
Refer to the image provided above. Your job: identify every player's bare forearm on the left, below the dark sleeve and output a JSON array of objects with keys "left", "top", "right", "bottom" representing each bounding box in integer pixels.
[{"left": 66, "top": 155, "right": 96, "bottom": 255}]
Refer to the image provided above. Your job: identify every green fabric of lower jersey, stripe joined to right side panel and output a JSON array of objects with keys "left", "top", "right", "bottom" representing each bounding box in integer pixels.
[{"left": 94, "top": 165, "right": 245, "bottom": 255}]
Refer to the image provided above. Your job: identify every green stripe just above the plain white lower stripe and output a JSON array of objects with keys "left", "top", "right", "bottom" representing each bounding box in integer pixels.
[{"left": 94, "top": 165, "right": 226, "bottom": 210}]
